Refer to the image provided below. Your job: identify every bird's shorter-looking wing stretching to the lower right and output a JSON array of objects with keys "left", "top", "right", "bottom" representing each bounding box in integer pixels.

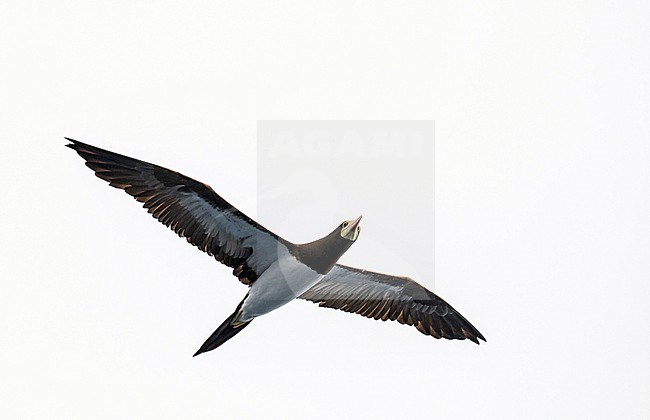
[{"left": 300, "top": 264, "right": 485, "bottom": 344}]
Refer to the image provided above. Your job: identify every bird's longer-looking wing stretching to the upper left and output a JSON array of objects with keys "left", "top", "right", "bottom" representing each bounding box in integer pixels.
[{"left": 66, "top": 138, "right": 293, "bottom": 285}]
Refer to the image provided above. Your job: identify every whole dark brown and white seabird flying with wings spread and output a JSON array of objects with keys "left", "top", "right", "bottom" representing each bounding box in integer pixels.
[{"left": 66, "top": 137, "right": 485, "bottom": 356}]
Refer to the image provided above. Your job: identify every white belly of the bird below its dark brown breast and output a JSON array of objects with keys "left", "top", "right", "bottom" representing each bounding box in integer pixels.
[{"left": 240, "top": 254, "right": 324, "bottom": 321}]
